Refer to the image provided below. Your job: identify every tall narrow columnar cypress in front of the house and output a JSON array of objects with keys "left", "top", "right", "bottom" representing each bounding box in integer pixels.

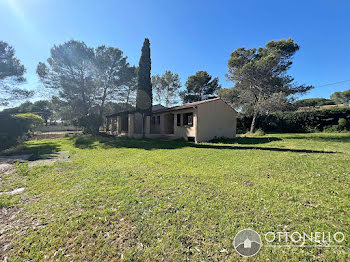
[{"left": 136, "top": 38, "right": 153, "bottom": 115}]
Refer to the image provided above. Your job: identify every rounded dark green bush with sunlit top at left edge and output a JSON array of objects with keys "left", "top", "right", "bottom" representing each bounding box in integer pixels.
[{"left": 0, "top": 113, "right": 44, "bottom": 150}]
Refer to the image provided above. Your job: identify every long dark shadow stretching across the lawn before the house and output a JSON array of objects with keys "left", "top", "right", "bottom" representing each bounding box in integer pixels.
[{"left": 72, "top": 136, "right": 337, "bottom": 154}]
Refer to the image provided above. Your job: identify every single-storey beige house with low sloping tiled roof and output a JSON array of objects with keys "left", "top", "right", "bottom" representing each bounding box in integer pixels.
[{"left": 106, "top": 98, "right": 237, "bottom": 142}]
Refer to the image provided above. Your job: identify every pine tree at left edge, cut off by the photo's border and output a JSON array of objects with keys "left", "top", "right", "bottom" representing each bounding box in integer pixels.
[{"left": 0, "top": 41, "right": 33, "bottom": 106}]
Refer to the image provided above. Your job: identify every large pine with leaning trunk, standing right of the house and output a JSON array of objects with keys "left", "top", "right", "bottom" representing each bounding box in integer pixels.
[{"left": 227, "top": 39, "right": 313, "bottom": 133}]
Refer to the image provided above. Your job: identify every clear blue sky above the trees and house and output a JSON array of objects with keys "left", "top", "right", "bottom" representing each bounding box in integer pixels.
[{"left": 0, "top": 0, "right": 350, "bottom": 105}]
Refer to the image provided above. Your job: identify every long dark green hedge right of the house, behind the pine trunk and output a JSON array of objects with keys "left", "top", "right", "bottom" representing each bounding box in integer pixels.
[{"left": 237, "top": 107, "right": 350, "bottom": 132}]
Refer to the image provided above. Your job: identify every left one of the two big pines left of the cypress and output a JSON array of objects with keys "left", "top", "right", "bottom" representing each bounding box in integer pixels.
[{"left": 37, "top": 40, "right": 97, "bottom": 117}]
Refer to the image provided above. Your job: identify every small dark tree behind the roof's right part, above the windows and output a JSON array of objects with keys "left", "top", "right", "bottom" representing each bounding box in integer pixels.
[{"left": 180, "top": 71, "right": 221, "bottom": 103}]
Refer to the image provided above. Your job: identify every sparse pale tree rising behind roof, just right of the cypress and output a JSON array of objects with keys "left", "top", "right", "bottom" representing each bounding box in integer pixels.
[{"left": 152, "top": 70, "right": 181, "bottom": 107}]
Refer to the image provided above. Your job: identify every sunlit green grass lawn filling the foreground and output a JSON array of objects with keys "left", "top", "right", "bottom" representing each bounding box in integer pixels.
[{"left": 0, "top": 133, "right": 350, "bottom": 261}]
